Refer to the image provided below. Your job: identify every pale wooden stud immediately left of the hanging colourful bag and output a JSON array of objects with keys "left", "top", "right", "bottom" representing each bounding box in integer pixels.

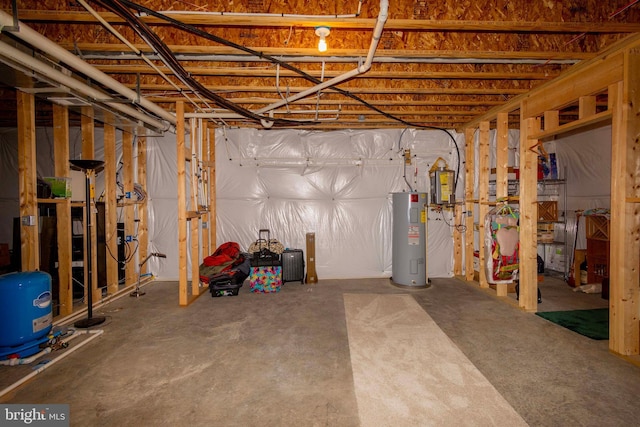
[{"left": 478, "top": 121, "right": 489, "bottom": 288}]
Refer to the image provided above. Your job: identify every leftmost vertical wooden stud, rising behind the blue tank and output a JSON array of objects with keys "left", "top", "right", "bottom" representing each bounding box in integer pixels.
[{"left": 13, "top": 91, "right": 40, "bottom": 271}]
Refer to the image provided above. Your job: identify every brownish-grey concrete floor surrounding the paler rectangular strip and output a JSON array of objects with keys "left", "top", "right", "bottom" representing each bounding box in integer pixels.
[{"left": 0, "top": 279, "right": 640, "bottom": 427}]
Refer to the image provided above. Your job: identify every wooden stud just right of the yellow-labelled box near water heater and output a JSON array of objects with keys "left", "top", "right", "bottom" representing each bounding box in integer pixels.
[{"left": 464, "top": 128, "right": 476, "bottom": 281}]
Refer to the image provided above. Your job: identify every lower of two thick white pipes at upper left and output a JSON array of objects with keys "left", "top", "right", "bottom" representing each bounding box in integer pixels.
[{"left": 0, "top": 42, "right": 168, "bottom": 134}]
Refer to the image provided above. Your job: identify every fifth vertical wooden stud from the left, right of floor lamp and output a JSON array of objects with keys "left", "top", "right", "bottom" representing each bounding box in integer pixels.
[{"left": 124, "top": 132, "right": 139, "bottom": 286}]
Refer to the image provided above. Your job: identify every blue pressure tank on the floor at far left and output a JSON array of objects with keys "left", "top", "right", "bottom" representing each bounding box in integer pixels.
[{"left": 0, "top": 271, "right": 53, "bottom": 358}]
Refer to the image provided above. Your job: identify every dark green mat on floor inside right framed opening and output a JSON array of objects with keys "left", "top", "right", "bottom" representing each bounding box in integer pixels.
[{"left": 536, "top": 308, "right": 609, "bottom": 340}]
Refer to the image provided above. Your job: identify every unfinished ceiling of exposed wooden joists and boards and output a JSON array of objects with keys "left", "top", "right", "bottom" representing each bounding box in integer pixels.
[{"left": 0, "top": 0, "right": 640, "bottom": 130}]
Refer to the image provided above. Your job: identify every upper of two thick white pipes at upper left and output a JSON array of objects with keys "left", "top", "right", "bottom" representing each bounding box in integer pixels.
[{"left": 0, "top": 10, "right": 176, "bottom": 129}]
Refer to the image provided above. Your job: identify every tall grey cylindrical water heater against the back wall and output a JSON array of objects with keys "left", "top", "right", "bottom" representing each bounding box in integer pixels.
[{"left": 391, "top": 192, "right": 428, "bottom": 288}]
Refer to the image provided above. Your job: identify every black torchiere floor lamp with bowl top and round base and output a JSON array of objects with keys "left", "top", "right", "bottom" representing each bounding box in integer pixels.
[{"left": 69, "top": 159, "right": 105, "bottom": 328}]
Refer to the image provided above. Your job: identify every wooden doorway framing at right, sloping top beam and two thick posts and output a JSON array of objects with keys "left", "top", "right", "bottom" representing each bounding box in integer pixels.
[{"left": 467, "top": 31, "right": 640, "bottom": 356}]
